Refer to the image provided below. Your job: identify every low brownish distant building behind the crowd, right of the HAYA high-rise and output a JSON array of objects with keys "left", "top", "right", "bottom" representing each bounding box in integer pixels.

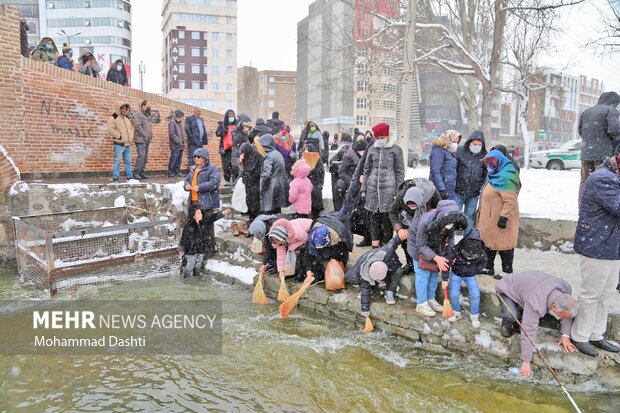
[{"left": 237, "top": 66, "right": 297, "bottom": 127}]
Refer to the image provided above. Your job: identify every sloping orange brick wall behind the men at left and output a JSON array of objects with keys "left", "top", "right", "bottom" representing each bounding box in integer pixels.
[{"left": 0, "top": 5, "right": 222, "bottom": 176}]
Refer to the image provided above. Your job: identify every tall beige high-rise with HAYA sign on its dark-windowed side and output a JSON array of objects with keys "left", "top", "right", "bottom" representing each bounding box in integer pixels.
[{"left": 162, "top": 0, "right": 237, "bottom": 113}]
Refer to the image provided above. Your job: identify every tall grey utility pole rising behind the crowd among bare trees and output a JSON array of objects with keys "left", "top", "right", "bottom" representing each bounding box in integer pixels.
[{"left": 397, "top": 0, "right": 419, "bottom": 168}]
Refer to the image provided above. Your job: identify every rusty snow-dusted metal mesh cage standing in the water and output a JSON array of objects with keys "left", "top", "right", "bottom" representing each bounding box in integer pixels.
[{"left": 13, "top": 207, "right": 179, "bottom": 295}]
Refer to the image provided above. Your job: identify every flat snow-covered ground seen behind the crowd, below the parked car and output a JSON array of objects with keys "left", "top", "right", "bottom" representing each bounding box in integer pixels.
[{"left": 323, "top": 167, "right": 580, "bottom": 221}]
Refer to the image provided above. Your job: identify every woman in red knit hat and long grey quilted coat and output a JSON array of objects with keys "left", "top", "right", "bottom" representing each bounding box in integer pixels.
[{"left": 360, "top": 123, "right": 405, "bottom": 248}]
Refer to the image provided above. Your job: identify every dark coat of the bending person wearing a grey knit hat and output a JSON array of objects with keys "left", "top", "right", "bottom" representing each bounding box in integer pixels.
[{"left": 344, "top": 235, "right": 402, "bottom": 312}]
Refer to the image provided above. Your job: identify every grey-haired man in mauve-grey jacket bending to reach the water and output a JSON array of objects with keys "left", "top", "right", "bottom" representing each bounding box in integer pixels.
[{"left": 495, "top": 271, "right": 577, "bottom": 377}]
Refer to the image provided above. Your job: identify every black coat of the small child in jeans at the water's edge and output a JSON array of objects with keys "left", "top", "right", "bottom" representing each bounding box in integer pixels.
[{"left": 442, "top": 228, "right": 487, "bottom": 281}]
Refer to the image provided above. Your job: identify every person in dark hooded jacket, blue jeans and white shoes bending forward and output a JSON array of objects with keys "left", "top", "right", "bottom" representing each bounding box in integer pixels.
[{"left": 414, "top": 200, "right": 467, "bottom": 317}]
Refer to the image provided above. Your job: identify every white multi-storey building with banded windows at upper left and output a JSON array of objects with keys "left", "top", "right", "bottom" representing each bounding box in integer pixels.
[{"left": 38, "top": 0, "right": 131, "bottom": 80}]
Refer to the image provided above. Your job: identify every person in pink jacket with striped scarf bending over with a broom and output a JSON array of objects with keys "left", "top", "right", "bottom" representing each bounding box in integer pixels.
[{"left": 267, "top": 218, "right": 312, "bottom": 278}]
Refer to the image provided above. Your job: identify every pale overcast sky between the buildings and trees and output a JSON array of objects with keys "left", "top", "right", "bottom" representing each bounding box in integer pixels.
[{"left": 131, "top": 0, "right": 620, "bottom": 93}]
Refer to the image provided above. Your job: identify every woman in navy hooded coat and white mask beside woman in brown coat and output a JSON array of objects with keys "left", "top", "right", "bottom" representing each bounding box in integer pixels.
[{"left": 454, "top": 130, "right": 487, "bottom": 236}]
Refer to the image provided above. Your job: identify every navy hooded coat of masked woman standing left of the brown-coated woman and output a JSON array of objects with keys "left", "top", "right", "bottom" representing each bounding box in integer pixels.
[{"left": 456, "top": 131, "right": 487, "bottom": 198}]
